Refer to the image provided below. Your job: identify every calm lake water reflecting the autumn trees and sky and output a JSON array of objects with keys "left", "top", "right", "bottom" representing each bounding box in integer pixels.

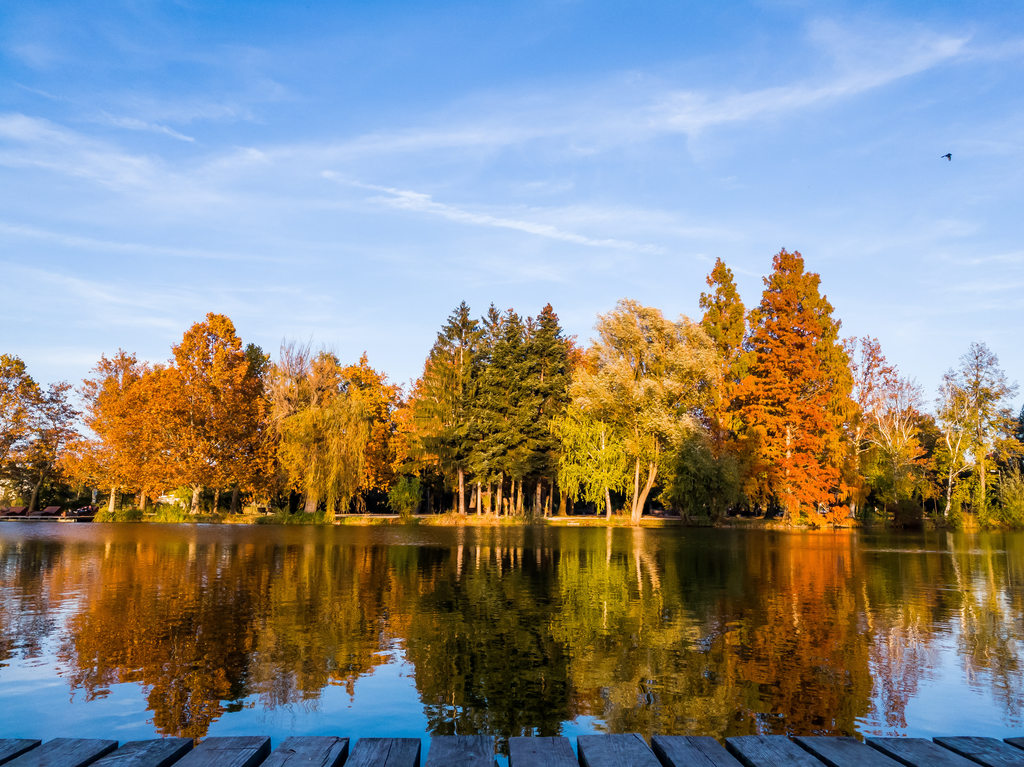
[{"left": 0, "top": 523, "right": 1024, "bottom": 741}]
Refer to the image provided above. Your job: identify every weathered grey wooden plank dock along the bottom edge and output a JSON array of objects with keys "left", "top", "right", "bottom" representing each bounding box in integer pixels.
[{"left": 0, "top": 734, "right": 1024, "bottom": 767}]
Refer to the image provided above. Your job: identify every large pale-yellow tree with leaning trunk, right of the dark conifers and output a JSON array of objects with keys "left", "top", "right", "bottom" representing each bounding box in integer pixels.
[{"left": 569, "top": 299, "right": 720, "bottom": 524}]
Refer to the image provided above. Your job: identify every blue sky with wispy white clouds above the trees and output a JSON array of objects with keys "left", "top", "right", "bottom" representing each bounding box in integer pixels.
[{"left": 0, "top": 0, "right": 1024, "bottom": 413}]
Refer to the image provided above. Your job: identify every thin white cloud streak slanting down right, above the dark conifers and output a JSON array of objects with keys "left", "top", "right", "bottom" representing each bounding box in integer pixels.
[{"left": 322, "top": 171, "right": 665, "bottom": 254}]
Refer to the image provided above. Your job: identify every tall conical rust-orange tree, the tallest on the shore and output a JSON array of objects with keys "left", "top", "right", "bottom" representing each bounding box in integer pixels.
[{"left": 738, "top": 249, "right": 854, "bottom": 521}]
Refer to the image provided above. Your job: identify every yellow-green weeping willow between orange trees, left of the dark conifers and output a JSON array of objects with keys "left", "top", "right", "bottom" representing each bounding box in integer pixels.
[{"left": 266, "top": 345, "right": 371, "bottom": 514}]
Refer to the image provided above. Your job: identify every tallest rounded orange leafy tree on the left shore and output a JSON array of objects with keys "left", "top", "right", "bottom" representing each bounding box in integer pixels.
[{"left": 164, "top": 312, "right": 268, "bottom": 514}]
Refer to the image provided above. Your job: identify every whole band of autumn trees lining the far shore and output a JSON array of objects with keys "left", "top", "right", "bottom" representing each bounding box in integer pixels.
[{"left": 0, "top": 250, "right": 1024, "bottom": 526}]
